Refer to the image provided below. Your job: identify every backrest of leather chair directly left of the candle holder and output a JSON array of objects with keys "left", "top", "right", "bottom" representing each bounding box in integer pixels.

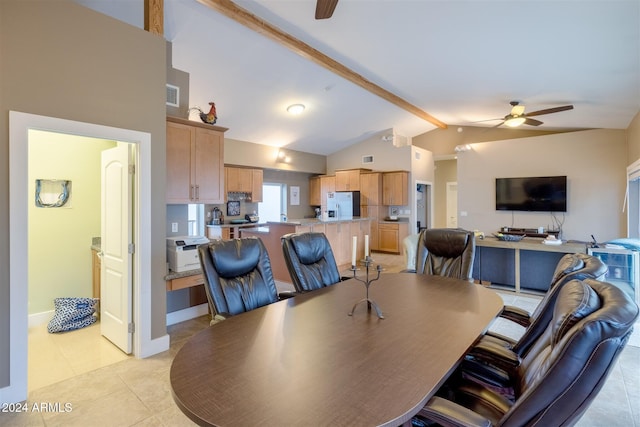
[{"left": 281, "top": 232, "right": 340, "bottom": 292}]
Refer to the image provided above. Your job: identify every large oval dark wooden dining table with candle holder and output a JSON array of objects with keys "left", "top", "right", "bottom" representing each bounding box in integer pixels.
[{"left": 170, "top": 272, "right": 503, "bottom": 427}]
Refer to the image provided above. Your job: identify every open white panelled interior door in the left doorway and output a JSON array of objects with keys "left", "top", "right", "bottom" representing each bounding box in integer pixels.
[{"left": 100, "top": 143, "right": 133, "bottom": 354}]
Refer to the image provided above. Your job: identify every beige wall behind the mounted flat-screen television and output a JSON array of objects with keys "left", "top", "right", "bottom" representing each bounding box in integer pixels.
[{"left": 458, "top": 130, "right": 627, "bottom": 241}]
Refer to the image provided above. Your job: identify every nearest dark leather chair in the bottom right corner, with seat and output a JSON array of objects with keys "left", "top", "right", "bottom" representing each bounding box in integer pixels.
[{"left": 419, "top": 279, "right": 638, "bottom": 427}]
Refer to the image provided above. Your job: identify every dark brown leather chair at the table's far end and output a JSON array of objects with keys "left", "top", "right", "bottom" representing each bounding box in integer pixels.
[{"left": 416, "top": 228, "right": 476, "bottom": 281}]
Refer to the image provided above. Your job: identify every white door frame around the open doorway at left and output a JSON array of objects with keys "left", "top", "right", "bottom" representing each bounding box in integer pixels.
[{"left": 7, "top": 111, "right": 162, "bottom": 402}]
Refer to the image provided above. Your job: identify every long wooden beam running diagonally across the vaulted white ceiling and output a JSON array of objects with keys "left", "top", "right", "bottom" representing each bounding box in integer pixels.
[{"left": 198, "top": 0, "right": 447, "bottom": 129}]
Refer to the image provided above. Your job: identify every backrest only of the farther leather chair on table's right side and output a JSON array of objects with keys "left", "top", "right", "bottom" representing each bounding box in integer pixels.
[{"left": 513, "top": 253, "right": 607, "bottom": 357}]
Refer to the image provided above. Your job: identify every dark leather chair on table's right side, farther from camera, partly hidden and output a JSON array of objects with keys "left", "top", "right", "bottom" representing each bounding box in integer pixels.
[{"left": 472, "top": 253, "right": 607, "bottom": 372}]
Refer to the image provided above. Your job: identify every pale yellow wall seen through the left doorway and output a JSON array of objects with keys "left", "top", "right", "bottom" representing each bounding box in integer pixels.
[{"left": 28, "top": 130, "right": 116, "bottom": 314}]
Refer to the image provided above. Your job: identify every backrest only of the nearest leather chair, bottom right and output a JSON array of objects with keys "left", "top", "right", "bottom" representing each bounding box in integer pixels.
[{"left": 499, "top": 279, "right": 638, "bottom": 426}]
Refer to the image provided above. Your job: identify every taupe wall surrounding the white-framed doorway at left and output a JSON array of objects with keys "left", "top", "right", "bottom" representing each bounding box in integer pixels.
[{"left": 0, "top": 0, "right": 166, "bottom": 387}]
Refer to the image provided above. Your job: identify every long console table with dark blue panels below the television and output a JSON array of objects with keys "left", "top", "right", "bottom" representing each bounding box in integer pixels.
[{"left": 473, "top": 237, "right": 587, "bottom": 292}]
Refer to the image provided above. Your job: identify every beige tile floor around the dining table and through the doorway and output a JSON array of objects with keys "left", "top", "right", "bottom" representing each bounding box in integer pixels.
[{"left": 0, "top": 254, "right": 640, "bottom": 427}]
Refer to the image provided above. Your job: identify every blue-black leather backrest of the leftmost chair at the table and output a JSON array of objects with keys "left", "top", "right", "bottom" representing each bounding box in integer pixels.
[{"left": 198, "top": 237, "right": 278, "bottom": 315}]
